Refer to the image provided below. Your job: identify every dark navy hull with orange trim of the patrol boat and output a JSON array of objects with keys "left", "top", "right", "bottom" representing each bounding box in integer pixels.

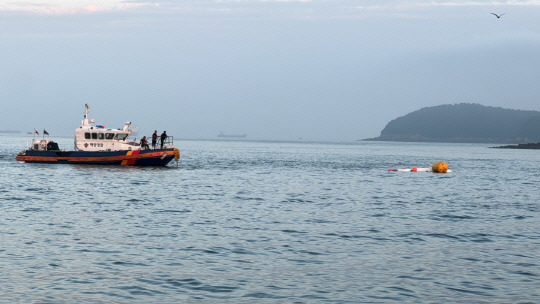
[{"left": 17, "top": 149, "right": 180, "bottom": 166}]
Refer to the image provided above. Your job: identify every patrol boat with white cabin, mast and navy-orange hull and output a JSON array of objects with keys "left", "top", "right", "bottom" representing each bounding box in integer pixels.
[{"left": 17, "top": 104, "right": 180, "bottom": 166}]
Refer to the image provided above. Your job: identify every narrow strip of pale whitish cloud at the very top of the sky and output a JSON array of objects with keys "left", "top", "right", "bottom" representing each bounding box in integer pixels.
[{"left": 0, "top": 0, "right": 540, "bottom": 15}]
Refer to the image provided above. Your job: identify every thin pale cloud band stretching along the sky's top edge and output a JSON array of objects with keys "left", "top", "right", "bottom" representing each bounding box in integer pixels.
[{"left": 0, "top": 0, "right": 540, "bottom": 19}]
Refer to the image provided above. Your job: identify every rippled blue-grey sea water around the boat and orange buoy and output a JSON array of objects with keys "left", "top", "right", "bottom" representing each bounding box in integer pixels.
[{"left": 0, "top": 134, "right": 540, "bottom": 303}]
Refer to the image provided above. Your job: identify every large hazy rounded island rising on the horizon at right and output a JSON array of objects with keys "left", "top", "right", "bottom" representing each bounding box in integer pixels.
[{"left": 364, "top": 103, "right": 540, "bottom": 144}]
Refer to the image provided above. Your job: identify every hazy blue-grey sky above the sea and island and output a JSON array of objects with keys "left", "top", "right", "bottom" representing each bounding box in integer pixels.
[{"left": 0, "top": 0, "right": 540, "bottom": 141}]
